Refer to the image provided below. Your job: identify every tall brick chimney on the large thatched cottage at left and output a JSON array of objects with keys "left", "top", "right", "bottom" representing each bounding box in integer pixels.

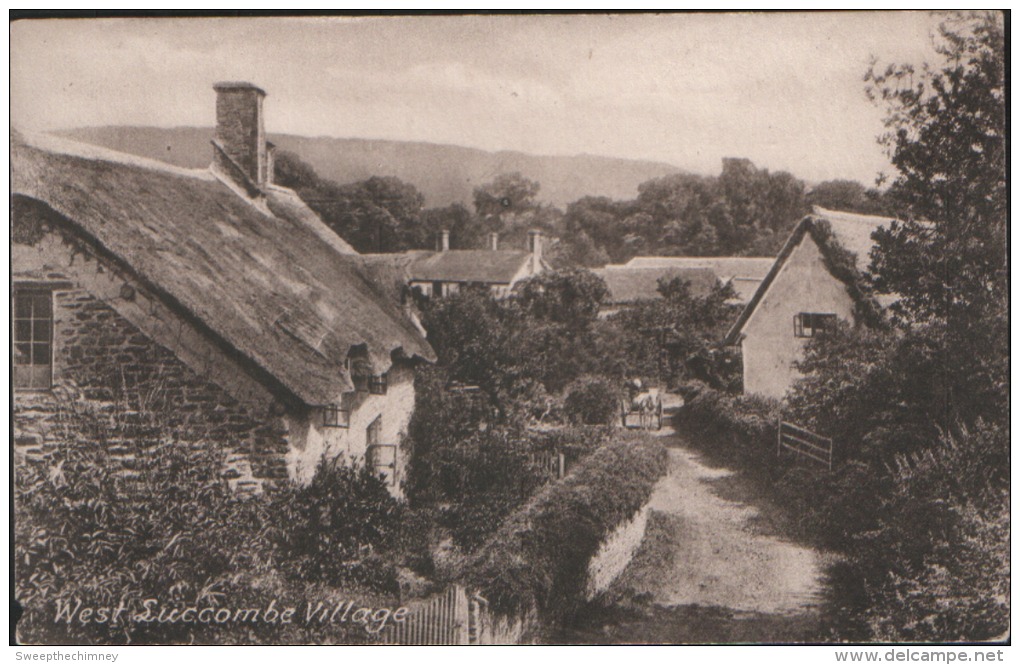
[{"left": 212, "top": 82, "right": 270, "bottom": 196}]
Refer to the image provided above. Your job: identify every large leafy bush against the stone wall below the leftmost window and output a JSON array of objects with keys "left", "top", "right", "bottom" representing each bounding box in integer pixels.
[{"left": 14, "top": 395, "right": 272, "bottom": 644}]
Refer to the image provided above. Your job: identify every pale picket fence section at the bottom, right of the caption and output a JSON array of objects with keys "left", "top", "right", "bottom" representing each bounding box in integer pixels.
[{"left": 383, "top": 584, "right": 468, "bottom": 645}]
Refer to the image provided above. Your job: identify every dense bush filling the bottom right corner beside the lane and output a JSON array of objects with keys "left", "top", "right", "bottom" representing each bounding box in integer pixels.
[{"left": 852, "top": 422, "right": 1010, "bottom": 642}]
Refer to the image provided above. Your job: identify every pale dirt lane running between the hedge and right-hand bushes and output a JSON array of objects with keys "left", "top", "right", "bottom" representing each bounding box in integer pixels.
[{"left": 550, "top": 428, "right": 822, "bottom": 644}]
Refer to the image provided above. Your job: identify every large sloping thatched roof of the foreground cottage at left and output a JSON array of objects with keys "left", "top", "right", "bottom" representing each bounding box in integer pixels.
[{"left": 11, "top": 134, "right": 435, "bottom": 405}]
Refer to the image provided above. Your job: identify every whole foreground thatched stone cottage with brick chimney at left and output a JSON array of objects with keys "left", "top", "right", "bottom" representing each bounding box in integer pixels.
[{"left": 11, "top": 83, "right": 435, "bottom": 492}]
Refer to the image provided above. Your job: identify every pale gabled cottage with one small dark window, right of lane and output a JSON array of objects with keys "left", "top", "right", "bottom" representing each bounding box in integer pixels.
[{"left": 725, "top": 207, "right": 891, "bottom": 398}]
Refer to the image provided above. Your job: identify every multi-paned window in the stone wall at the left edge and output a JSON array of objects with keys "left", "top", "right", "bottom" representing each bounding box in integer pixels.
[{"left": 11, "top": 290, "right": 53, "bottom": 390}]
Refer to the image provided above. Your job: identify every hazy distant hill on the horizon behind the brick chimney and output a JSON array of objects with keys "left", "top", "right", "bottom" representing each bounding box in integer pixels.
[{"left": 59, "top": 126, "right": 680, "bottom": 207}]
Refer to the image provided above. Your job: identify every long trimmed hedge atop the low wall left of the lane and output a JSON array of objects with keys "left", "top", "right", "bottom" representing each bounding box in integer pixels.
[{"left": 460, "top": 434, "right": 667, "bottom": 618}]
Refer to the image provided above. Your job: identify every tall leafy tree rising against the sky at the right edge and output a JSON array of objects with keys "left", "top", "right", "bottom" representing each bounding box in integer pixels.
[{"left": 867, "top": 13, "right": 1009, "bottom": 426}]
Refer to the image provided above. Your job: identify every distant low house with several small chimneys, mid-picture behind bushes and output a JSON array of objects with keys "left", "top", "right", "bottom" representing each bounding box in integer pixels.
[{"left": 366, "top": 231, "right": 549, "bottom": 298}]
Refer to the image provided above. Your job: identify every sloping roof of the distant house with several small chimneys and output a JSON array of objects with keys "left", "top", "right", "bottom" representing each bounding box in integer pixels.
[{"left": 393, "top": 250, "right": 533, "bottom": 285}]
